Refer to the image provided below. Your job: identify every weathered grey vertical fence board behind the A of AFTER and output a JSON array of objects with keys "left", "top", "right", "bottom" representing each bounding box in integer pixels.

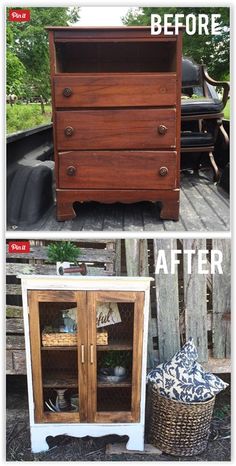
[{"left": 153, "top": 239, "right": 180, "bottom": 362}]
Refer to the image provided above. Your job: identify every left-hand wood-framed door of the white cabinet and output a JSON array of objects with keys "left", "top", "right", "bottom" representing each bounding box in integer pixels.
[{"left": 29, "top": 291, "right": 87, "bottom": 422}]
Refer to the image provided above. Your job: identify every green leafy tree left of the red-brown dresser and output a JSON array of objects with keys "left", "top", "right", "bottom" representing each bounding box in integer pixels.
[{"left": 7, "top": 7, "right": 79, "bottom": 107}]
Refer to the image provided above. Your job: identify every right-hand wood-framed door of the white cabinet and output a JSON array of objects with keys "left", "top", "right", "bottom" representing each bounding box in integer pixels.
[{"left": 87, "top": 291, "right": 144, "bottom": 422}]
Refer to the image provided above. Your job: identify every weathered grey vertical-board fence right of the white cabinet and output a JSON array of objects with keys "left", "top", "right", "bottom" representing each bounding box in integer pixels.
[{"left": 125, "top": 239, "right": 231, "bottom": 373}]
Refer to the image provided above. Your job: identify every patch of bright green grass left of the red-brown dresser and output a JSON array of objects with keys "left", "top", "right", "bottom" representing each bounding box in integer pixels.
[{"left": 6, "top": 103, "right": 52, "bottom": 134}]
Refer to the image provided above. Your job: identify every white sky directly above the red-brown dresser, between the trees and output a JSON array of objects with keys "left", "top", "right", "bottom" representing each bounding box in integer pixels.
[{"left": 78, "top": 6, "right": 132, "bottom": 26}]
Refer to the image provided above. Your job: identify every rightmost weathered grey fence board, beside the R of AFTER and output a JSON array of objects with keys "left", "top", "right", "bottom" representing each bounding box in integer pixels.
[{"left": 212, "top": 238, "right": 231, "bottom": 358}]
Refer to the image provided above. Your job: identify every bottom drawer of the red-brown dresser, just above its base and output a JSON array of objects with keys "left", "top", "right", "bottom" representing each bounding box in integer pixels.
[{"left": 58, "top": 151, "right": 177, "bottom": 189}]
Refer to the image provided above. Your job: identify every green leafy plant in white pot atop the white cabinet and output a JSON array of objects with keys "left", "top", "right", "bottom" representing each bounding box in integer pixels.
[{"left": 47, "top": 241, "right": 87, "bottom": 275}]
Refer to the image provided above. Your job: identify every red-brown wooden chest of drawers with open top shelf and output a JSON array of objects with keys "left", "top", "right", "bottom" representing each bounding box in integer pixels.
[{"left": 48, "top": 27, "right": 181, "bottom": 220}]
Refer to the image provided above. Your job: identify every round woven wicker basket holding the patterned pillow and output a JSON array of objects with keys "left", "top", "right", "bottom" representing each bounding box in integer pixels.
[{"left": 149, "top": 386, "right": 215, "bottom": 456}]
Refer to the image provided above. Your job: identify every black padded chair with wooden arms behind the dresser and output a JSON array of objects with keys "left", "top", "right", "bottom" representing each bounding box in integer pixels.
[{"left": 181, "top": 58, "right": 229, "bottom": 181}]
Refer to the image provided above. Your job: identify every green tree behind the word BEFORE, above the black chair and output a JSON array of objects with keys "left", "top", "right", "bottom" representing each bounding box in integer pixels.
[{"left": 122, "top": 7, "right": 230, "bottom": 80}]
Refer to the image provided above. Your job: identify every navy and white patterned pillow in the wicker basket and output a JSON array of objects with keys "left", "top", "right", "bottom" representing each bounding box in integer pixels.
[{"left": 147, "top": 338, "right": 228, "bottom": 403}]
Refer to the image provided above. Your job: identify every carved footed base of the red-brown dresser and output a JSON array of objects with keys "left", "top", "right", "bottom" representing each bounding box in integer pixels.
[{"left": 57, "top": 189, "right": 179, "bottom": 221}]
